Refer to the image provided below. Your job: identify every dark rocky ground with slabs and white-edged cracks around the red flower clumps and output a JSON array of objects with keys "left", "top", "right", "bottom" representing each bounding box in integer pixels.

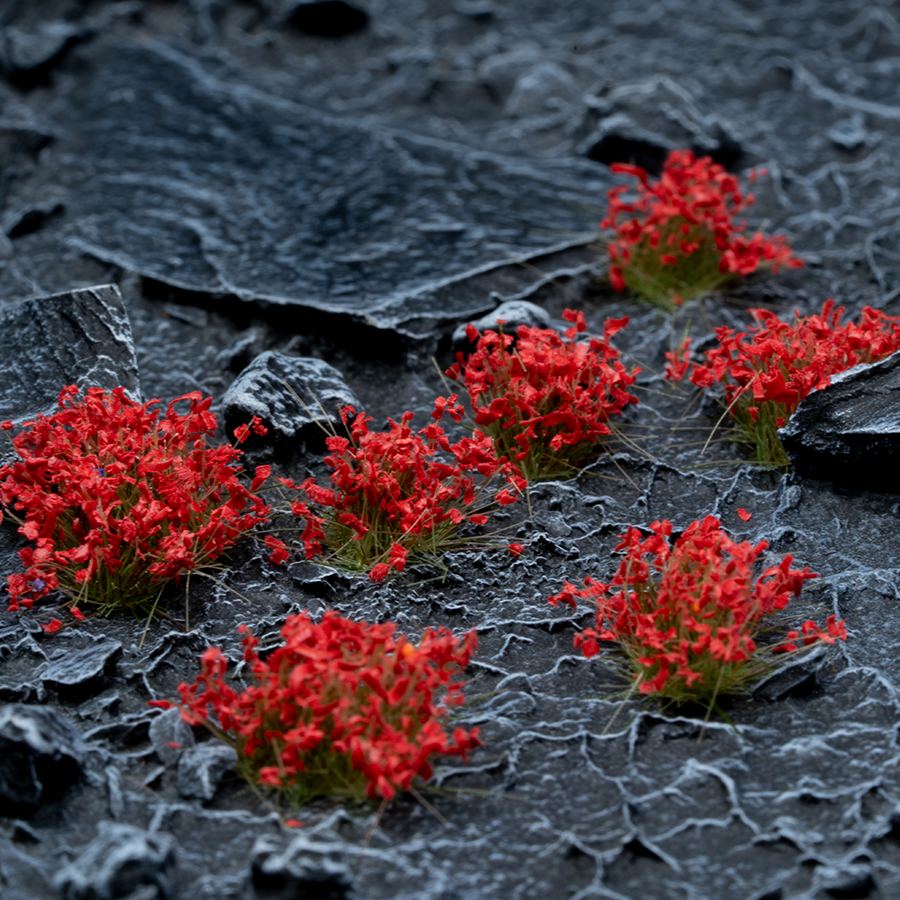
[{"left": 0, "top": 0, "right": 900, "bottom": 900}]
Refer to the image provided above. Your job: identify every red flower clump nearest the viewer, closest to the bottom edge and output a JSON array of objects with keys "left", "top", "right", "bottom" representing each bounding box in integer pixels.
[{"left": 170, "top": 611, "right": 478, "bottom": 802}]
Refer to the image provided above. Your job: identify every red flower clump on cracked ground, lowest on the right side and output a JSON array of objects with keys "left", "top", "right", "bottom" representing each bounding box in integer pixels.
[{"left": 550, "top": 516, "right": 846, "bottom": 702}]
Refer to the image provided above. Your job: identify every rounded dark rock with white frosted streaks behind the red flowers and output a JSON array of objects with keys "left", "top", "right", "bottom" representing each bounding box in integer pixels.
[{"left": 222, "top": 350, "right": 360, "bottom": 451}]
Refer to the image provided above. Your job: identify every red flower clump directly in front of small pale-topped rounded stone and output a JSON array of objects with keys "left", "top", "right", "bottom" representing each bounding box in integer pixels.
[{"left": 447, "top": 309, "right": 639, "bottom": 482}]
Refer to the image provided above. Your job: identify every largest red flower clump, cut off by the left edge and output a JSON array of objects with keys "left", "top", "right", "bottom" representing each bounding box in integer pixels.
[{"left": 0, "top": 386, "right": 268, "bottom": 618}]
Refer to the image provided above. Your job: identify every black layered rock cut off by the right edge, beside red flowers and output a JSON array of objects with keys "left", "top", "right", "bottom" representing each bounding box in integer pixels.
[{"left": 779, "top": 351, "right": 900, "bottom": 491}]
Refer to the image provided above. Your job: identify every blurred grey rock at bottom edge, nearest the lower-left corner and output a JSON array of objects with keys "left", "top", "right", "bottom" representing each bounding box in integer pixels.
[{"left": 55, "top": 821, "right": 175, "bottom": 900}]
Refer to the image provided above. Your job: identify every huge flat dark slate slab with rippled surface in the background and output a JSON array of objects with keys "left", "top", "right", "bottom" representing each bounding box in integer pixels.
[{"left": 53, "top": 43, "right": 604, "bottom": 327}]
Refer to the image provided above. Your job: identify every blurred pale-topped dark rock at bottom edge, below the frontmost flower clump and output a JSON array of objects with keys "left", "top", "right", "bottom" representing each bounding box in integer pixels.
[{"left": 252, "top": 835, "right": 353, "bottom": 900}]
